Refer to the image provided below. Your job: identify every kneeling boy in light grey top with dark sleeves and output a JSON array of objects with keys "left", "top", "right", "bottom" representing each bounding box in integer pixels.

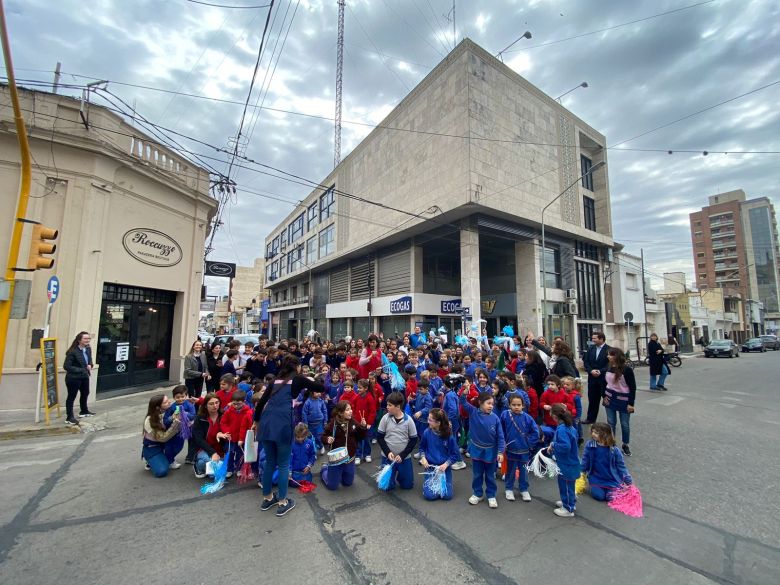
[{"left": 377, "top": 392, "right": 417, "bottom": 490}]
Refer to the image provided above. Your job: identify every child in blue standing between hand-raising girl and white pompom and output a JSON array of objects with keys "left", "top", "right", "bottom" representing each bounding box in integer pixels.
[{"left": 501, "top": 394, "right": 539, "bottom": 502}]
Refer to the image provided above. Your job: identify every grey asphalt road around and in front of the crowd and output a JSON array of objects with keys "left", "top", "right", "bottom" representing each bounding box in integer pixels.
[{"left": 0, "top": 352, "right": 780, "bottom": 585}]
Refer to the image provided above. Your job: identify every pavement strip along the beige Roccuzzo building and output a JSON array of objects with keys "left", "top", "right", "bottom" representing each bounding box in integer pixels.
[{"left": 0, "top": 386, "right": 172, "bottom": 441}]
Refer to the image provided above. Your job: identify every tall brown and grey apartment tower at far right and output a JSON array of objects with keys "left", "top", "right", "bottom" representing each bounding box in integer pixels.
[{"left": 690, "top": 189, "right": 780, "bottom": 340}]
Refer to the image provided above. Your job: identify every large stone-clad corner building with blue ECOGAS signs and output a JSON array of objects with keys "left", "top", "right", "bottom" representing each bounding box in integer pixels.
[{"left": 265, "top": 40, "right": 613, "bottom": 354}]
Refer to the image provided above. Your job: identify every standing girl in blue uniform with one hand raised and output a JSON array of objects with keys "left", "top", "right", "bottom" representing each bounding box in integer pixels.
[{"left": 460, "top": 380, "right": 506, "bottom": 508}]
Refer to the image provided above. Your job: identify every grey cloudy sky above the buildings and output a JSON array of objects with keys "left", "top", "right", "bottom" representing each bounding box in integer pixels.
[{"left": 5, "top": 0, "right": 780, "bottom": 287}]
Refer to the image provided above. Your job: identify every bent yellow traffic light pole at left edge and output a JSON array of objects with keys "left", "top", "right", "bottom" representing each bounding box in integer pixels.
[{"left": 0, "top": 0, "right": 32, "bottom": 378}]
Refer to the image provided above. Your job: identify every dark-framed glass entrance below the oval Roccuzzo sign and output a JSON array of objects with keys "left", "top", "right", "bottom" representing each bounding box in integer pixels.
[{"left": 97, "top": 284, "right": 176, "bottom": 392}]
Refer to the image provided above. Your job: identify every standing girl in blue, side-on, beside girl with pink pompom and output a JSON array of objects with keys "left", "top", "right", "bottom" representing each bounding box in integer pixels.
[{"left": 547, "top": 402, "right": 580, "bottom": 518}]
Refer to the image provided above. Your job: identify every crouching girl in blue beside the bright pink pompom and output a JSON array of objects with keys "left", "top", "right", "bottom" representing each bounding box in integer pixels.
[{"left": 581, "top": 423, "right": 633, "bottom": 502}]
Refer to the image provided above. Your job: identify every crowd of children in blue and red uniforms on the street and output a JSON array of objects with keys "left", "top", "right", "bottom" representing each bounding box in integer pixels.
[{"left": 142, "top": 332, "right": 632, "bottom": 517}]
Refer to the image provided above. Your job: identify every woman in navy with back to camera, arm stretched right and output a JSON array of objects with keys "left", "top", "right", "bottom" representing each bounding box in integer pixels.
[{"left": 254, "top": 354, "right": 325, "bottom": 516}]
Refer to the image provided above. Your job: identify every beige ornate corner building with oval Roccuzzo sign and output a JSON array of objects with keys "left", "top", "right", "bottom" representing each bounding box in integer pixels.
[{"left": 0, "top": 86, "right": 217, "bottom": 408}]
